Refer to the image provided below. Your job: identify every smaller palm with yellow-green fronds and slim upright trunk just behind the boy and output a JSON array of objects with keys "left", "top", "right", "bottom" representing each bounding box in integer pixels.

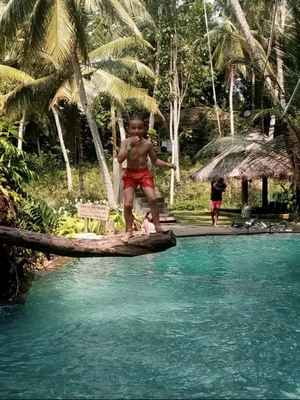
[{"left": 85, "top": 37, "right": 159, "bottom": 204}]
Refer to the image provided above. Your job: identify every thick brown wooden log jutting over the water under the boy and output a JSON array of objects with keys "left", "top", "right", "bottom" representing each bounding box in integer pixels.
[{"left": 0, "top": 226, "right": 176, "bottom": 257}]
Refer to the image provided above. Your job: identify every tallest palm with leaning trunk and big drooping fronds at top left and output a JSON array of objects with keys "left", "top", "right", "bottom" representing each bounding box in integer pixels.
[{"left": 0, "top": 0, "right": 155, "bottom": 208}]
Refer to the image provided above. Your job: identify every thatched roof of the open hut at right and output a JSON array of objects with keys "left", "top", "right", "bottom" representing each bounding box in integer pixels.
[{"left": 192, "top": 137, "right": 292, "bottom": 181}]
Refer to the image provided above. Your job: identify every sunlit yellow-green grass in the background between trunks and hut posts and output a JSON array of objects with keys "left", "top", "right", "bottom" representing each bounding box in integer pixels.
[{"left": 25, "top": 159, "right": 287, "bottom": 223}]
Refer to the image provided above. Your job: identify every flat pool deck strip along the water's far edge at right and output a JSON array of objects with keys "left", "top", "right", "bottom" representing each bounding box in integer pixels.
[{"left": 164, "top": 223, "right": 300, "bottom": 237}]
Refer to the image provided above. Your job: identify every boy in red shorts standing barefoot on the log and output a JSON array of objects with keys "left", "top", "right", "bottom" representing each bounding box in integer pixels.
[{"left": 118, "top": 115, "right": 176, "bottom": 241}]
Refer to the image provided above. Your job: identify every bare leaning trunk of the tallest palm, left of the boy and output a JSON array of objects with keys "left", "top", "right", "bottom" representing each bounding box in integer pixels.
[{"left": 73, "top": 55, "right": 117, "bottom": 209}]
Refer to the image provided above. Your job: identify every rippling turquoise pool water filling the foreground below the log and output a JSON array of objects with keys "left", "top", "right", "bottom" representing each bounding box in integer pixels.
[{"left": 0, "top": 235, "right": 300, "bottom": 399}]
